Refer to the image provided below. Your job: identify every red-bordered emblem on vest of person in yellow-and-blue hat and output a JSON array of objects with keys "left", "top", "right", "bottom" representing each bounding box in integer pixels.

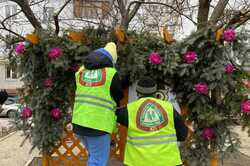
[{"left": 79, "top": 69, "right": 106, "bottom": 86}]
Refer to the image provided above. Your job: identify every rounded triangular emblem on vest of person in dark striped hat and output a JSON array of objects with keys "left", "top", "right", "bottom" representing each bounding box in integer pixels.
[{"left": 136, "top": 100, "right": 168, "bottom": 131}]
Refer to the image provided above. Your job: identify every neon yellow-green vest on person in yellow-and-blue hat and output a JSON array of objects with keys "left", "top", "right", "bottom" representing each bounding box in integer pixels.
[{"left": 72, "top": 68, "right": 116, "bottom": 133}]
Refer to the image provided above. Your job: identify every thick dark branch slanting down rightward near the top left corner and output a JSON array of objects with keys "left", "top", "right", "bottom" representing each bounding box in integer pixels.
[{"left": 10, "top": 0, "right": 42, "bottom": 30}]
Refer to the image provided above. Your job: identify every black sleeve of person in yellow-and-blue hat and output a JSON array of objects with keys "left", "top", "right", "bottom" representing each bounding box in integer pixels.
[{"left": 110, "top": 73, "right": 123, "bottom": 107}]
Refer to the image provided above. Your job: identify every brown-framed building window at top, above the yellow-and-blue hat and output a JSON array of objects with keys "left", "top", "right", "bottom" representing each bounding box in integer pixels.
[{"left": 74, "top": 0, "right": 110, "bottom": 19}]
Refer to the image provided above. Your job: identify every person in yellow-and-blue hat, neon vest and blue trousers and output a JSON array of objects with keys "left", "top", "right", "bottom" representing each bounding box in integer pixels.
[{"left": 72, "top": 42, "right": 123, "bottom": 166}]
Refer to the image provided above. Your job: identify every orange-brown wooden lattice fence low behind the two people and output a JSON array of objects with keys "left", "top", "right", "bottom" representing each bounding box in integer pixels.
[{"left": 42, "top": 124, "right": 126, "bottom": 166}]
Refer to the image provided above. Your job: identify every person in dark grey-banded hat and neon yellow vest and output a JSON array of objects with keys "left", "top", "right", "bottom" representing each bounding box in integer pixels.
[{"left": 116, "top": 77, "right": 188, "bottom": 166}]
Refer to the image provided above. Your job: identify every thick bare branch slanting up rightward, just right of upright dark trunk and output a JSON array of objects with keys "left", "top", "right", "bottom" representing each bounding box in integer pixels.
[{"left": 209, "top": 0, "right": 229, "bottom": 25}]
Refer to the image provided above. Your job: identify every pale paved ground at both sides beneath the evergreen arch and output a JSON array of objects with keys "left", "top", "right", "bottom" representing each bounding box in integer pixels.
[{"left": 0, "top": 122, "right": 250, "bottom": 166}]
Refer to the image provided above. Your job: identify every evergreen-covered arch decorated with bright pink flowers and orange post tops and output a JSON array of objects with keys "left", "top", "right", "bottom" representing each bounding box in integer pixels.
[{"left": 11, "top": 28, "right": 250, "bottom": 165}]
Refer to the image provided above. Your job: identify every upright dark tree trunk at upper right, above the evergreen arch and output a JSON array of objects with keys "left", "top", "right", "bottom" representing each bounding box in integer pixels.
[{"left": 197, "top": 0, "right": 210, "bottom": 30}]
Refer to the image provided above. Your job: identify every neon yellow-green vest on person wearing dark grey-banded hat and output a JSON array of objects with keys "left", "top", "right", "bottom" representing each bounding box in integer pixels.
[{"left": 124, "top": 97, "right": 182, "bottom": 166}]
